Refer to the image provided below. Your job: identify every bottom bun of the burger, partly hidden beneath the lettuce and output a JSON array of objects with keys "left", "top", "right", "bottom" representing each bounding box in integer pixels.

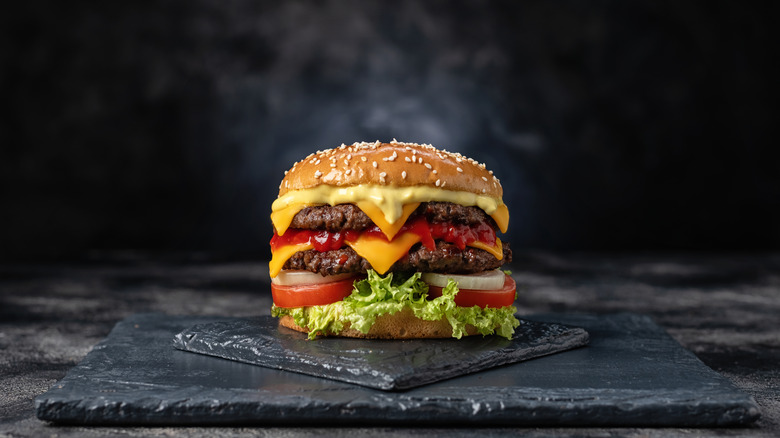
[{"left": 279, "top": 307, "right": 477, "bottom": 339}]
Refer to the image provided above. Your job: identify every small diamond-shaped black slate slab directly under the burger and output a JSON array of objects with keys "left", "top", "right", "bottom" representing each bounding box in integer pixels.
[{"left": 173, "top": 316, "right": 588, "bottom": 390}]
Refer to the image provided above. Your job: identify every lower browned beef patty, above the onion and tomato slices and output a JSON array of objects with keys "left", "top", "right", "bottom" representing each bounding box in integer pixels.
[{"left": 283, "top": 241, "right": 512, "bottom": 275}]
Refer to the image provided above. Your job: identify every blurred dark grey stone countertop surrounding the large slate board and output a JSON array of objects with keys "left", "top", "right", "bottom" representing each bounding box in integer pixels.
[{"left": 0, "top": 252, "right": 780, "bottom": 437}]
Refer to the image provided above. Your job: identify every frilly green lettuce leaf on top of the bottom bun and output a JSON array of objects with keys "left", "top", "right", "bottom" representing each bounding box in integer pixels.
[{"left": 271, "top": 270, "right": 520, "bottom": 339}]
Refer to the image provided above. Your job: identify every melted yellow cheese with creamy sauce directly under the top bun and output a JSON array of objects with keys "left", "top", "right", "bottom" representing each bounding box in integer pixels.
[{"left": 271, "top": 185, "right": 509, "bottom": 238}]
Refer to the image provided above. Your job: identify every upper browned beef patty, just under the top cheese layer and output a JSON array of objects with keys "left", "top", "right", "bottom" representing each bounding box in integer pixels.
[{"left": 290, "top": 202, "right": 497, "bottom": 231}]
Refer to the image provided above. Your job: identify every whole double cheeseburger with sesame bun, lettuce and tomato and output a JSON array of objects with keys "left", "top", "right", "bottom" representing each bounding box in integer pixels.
[{"left": 269, "top": 140, "right": 519, "bottom": 339}]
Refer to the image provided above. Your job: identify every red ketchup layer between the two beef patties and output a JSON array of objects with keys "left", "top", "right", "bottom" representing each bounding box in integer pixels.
[{"left": 271, "top": 217, "right": 496, "bottom": 252}]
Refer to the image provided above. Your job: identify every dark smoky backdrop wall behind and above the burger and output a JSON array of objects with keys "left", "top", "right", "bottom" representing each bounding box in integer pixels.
[{"left": 0, "top": 0, "right": 780, "bottom": 260}]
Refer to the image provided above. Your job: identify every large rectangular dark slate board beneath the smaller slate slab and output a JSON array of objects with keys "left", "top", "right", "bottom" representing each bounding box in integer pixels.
[{"left": 36, "top": 314, "right": 760, "bottom": 427}]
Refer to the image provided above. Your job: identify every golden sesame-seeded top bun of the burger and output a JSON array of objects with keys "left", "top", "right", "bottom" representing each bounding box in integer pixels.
[{"left": 279, "top": 141, "right": 503, "bottom": 198}]
